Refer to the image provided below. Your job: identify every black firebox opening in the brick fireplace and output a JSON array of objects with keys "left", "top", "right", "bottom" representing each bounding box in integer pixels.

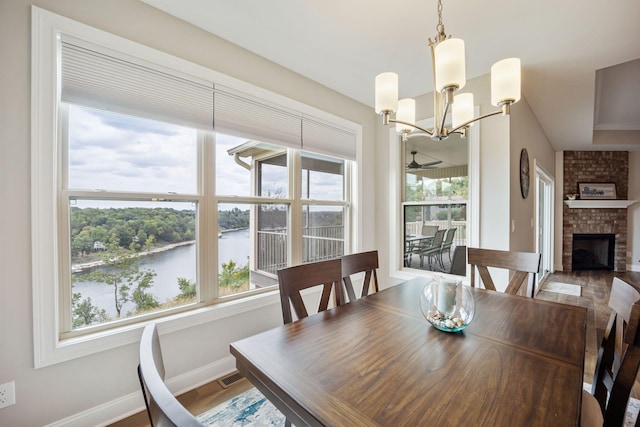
[{"left": 571, "top": 234, "right": 616, "bottom": 270}]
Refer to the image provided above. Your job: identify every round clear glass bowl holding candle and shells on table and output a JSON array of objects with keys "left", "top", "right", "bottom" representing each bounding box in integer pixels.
[{"left": 420, "top": 277, "right": 476, "bottom": 332}]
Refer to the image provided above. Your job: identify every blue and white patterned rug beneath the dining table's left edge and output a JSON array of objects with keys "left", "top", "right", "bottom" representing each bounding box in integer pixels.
[{"left": 198, "top": 388, "right": 285, "bottom": 427}]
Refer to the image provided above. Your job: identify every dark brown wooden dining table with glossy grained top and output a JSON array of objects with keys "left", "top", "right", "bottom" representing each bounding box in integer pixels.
[{"left": 231, "top": 277, "right": 587, "bottom": 427}]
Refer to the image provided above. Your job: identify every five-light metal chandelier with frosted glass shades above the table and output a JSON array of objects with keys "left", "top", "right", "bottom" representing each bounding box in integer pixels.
[{"left": 375, "top": 0, "right": 520, "bottom": 141}]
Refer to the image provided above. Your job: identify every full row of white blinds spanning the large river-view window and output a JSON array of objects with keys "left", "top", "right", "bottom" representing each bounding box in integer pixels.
[{"left": 60, "top": 36, "right": 356, "bottom": 160}]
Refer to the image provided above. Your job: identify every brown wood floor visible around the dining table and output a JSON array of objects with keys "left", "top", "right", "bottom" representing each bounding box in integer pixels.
[{"left": 111, "top": 271, "right": 640, "bottom": 427}]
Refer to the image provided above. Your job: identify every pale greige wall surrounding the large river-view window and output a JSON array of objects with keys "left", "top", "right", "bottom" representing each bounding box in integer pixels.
[{"left": 0, "top": 0, "right": 376, "bottom": 427}]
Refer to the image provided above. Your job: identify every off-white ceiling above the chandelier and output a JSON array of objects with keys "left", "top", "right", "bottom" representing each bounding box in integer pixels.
[{"left": 142, "top": 0, "right": 640, "bottom": 151}]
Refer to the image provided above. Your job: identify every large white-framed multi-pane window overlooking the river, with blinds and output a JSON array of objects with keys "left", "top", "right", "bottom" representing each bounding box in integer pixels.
[{"left": 32, "top": 8, "right": 361, "bottom": 367}]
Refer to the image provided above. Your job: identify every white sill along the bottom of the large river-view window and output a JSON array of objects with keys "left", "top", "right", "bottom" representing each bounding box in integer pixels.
[{"left": 35, "top": 290, "right": 280, "bottom": 368}]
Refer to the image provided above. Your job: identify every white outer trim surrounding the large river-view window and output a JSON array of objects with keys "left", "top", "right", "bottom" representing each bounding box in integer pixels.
[{"left": 31, "top": 6, "right": 362, "bottom": 368}]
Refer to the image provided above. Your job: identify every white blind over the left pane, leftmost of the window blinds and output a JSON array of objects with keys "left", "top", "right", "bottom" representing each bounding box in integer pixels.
[{"left": 60, "top": 38, "right": 213, "bottom": 130}]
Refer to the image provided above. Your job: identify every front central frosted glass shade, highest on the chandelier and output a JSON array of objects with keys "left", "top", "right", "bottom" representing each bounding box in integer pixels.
[{"left": 434, "top": 39, "right": 467, "bottom": 92}]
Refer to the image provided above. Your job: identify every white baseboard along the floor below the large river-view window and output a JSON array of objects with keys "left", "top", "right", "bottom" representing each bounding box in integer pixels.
[{"left": 44, "top": 355, "right": 236, "bottom": 427}]
